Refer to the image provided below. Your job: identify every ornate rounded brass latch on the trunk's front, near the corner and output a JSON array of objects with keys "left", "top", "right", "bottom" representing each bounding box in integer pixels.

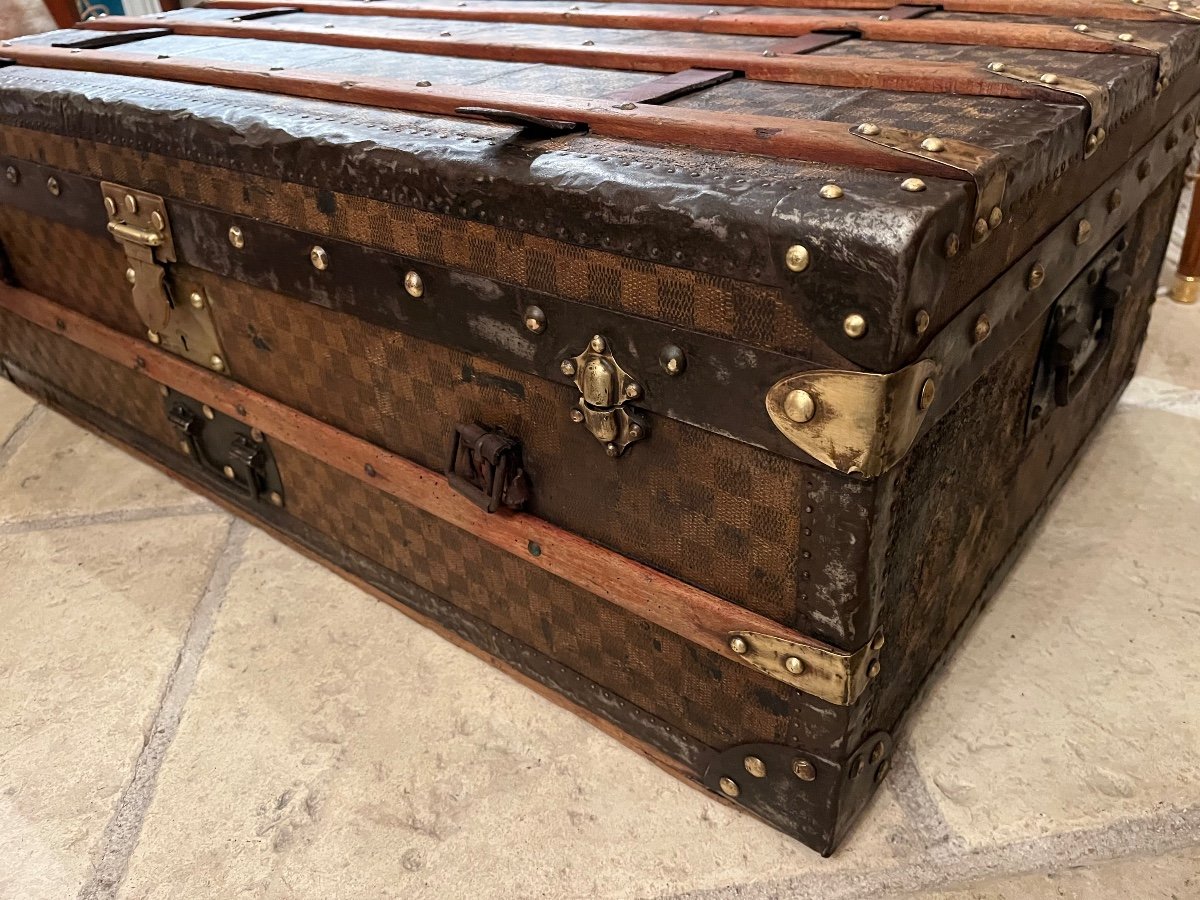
[{"left": 562, "top": 335, "right": 649, "bottom": 457}]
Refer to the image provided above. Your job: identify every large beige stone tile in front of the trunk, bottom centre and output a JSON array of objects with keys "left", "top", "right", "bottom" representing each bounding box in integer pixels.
[{"left": 121, "top": 534, "right": 911, "bottom": 900}]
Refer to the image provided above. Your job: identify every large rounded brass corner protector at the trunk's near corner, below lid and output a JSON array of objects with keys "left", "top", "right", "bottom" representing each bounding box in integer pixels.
[{"left": 767, "top": 359, "right": 938, "bottom": 478}]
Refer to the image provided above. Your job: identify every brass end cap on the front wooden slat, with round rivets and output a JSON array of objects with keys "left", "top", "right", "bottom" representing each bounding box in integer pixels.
[{"left": 730, "top": 631, "right": 880, "bottom": 706}]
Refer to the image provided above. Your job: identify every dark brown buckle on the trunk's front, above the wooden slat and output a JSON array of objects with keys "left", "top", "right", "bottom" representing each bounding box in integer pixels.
[{"left": 446, "top": 425, "right": 529, "bottom": 512}]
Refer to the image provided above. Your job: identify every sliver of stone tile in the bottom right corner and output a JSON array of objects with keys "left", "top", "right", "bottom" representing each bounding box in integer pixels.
[{"left": 892, "top": 847, "right": 1200, "bottom": 900}]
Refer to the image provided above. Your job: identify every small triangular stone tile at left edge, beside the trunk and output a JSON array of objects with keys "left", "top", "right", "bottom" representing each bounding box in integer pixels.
[{"left": 0, "top": 412, "right": 207, "bottom": 523}]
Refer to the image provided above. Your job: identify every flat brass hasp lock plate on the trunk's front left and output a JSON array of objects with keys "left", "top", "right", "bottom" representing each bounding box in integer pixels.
[{"left": 100, "top": 181, "right": 228, "bottom": 372}]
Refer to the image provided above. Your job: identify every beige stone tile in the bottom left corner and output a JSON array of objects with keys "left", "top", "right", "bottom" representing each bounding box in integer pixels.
[{"left": 0, "top": 513, "right": 226, "bottom": 900}]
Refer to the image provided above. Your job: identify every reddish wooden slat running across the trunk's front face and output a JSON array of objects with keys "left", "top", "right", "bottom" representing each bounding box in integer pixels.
[{"left": 0, "top": 286, "right": 875, "bottom": 704}]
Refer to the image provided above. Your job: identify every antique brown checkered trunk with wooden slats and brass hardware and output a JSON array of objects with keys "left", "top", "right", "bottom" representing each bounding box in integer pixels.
[{"left": 0, "top": 0, "right": 1200, "bottom": 853}]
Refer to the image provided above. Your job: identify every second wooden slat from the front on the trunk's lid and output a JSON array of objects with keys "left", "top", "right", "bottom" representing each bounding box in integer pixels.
[{"left": 72, "top": 16, "right": 1089, "bottom": 102}]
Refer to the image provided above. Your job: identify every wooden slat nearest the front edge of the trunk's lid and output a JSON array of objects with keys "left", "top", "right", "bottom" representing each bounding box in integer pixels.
[{"left": 4, "top": 46, "right": 993, "bottom": 181}]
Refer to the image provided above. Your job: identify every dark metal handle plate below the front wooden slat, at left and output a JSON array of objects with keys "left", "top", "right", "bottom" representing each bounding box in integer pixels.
[{"left": 163, "top": 388, "right": 283, "bottom": 506}]
